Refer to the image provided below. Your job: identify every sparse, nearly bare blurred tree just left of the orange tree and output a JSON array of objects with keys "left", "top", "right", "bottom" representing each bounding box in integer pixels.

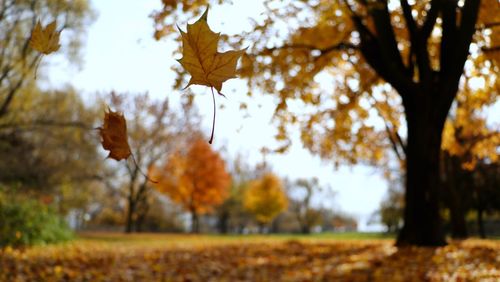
[{"left": 104, "top": 92, "right": 190, "bottom": 233}]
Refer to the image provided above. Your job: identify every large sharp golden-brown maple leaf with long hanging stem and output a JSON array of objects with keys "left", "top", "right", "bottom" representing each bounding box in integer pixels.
[{"left": 179, "top": 7, "right": 246, "bottom": 143}]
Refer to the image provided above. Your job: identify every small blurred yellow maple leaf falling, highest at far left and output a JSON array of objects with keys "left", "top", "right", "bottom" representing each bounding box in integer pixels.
[{"left": 30, "top": 20, "right": 61, "bottom": 55}]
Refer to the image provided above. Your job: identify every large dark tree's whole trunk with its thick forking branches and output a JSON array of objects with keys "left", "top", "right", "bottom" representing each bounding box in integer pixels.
[{"left": 345, "top": 0, "right": 480, "bottom": 246}]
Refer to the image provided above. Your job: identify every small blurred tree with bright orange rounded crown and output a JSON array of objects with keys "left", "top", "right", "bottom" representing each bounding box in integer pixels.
[{"left": 151, "top": 138, "right": 231, "bottom": 233}]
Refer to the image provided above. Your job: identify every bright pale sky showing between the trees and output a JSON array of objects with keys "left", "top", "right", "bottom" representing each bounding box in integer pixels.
[{"left": 49, "top": 0, "right": 386, "bottom": 231}]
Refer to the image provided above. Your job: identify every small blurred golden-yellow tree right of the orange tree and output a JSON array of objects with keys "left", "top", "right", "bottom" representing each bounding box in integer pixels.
[{"left": 243, "top": 172, "right": 288, "bottom": 232}]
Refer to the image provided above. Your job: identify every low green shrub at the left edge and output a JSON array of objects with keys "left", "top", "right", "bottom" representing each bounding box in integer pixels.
[{"left": 0, "top": 197, "right": 73, "bottom": 247}]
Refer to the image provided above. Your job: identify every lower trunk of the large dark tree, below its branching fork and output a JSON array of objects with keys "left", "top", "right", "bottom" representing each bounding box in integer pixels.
[{"left": 396, "top": 102, "right": 446, "bottom": 246}]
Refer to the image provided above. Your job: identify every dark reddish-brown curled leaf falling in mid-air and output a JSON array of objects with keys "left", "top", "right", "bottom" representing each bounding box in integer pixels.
[{"left": 98, "top": 108, "right": 132, "bottom": 161}]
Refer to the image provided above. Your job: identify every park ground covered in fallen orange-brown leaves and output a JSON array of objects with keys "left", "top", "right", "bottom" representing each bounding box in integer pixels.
[{"left": 0, "top": 234, "right": 500, "bottom": 281}]
